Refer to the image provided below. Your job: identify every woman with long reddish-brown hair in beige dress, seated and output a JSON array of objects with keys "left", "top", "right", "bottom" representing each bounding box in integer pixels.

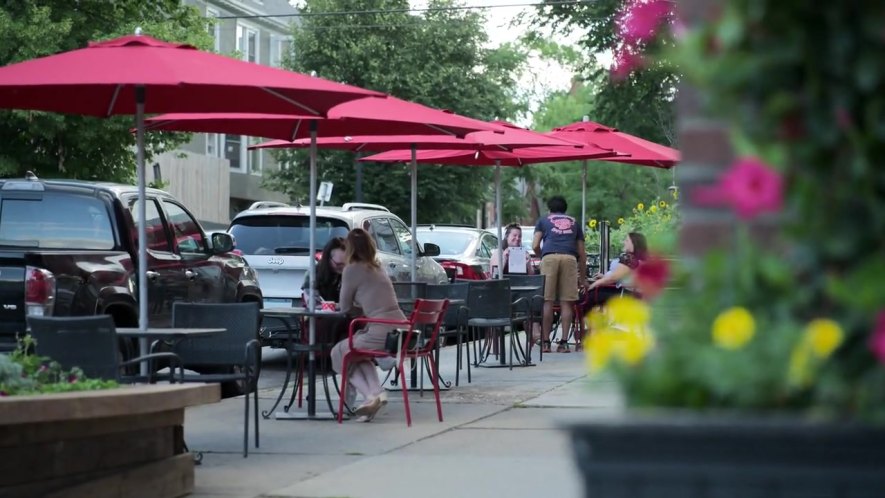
[{"left": 331, "top": 228, "right": 406, "bottom": 422}]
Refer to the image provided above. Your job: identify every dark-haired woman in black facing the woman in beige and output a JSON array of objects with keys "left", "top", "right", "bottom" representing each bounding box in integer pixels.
[{"left": 301, "top": 237, "right": 349, "bottom": 344}]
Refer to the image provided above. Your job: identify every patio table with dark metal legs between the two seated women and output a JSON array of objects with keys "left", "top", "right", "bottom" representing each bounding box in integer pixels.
[{"left": 260, "top": 307, "right": 347, "bottom": 420}]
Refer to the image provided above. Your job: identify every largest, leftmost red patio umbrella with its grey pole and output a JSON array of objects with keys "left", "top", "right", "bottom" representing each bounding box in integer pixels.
[{"left": 0, "top": 34, "right": 383, "bottom": 404}]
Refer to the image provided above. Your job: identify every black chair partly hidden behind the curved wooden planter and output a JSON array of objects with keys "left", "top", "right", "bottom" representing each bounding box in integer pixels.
[{"left": 28, "top": 315, "right": 183, "bottom": 382}]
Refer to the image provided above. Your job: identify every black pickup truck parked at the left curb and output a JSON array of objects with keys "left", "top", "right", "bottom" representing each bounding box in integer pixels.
[{"left": 0, "top": 175, "right": 262, "bottom": 351}]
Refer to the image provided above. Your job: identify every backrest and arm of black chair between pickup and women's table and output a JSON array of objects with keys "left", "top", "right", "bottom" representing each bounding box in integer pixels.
[{"left": 172, "top": 302, "right": 259, "bottom": 366}]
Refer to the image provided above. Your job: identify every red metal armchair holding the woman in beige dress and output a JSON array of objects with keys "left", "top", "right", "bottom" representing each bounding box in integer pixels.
[{"left": 338, "top": 299, "right": 449, "bottom": 426}]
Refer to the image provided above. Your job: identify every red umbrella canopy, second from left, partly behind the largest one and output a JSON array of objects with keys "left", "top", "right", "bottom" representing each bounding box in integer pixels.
[{"left": 145, "top": 97, "right": 499, "bottom": 142}]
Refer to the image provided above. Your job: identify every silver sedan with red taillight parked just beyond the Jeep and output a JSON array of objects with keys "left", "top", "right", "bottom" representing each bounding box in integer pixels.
[{"left": 418, "top": 225, "right": 498, "bottom": 280}]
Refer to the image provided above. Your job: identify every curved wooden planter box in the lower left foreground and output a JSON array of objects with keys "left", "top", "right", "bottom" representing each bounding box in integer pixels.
[{"left": 0, "top": 384, "right": 220, "bottom": 498}]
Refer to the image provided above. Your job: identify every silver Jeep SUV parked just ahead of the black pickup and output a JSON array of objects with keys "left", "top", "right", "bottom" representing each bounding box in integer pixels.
[{"left": 228, "top": 203, "right": 448, "bottom": 347}]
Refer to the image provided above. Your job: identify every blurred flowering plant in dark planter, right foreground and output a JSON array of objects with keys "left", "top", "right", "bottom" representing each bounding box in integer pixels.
[{"left": 570, "top": 0, "right": 885, "bottom": 498}]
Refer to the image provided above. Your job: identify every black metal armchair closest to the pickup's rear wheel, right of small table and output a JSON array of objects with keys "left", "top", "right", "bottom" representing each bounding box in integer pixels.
[{"left": 172, "top": 302, "right": 261, "bottom": 457}]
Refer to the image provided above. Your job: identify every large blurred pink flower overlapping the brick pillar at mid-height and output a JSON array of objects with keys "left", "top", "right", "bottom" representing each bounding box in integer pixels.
[{"left": 692, "top": 157, "right": 783, "bottom": 220}]
